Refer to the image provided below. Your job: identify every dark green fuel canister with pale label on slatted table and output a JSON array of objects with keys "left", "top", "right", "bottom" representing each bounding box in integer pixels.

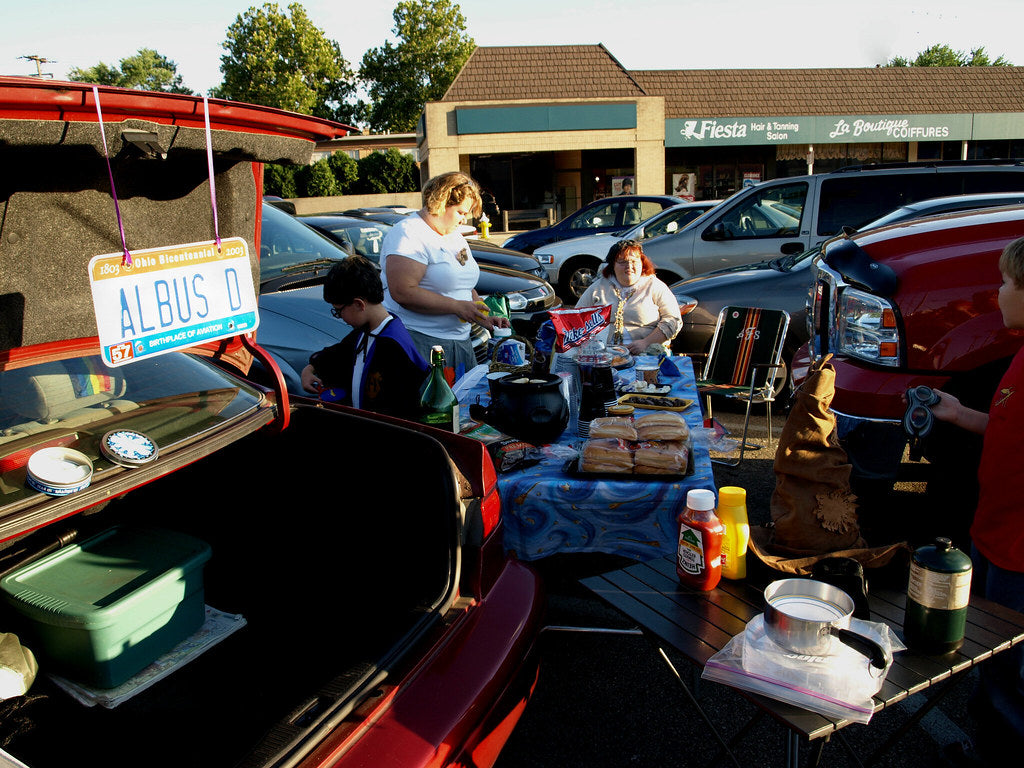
[{"left": 903, "top": 537, "right": 971, "bottom": 653}]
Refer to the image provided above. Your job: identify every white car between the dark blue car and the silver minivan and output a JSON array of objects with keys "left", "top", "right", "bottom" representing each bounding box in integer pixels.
[{"left": 534, "top": 200, "right": 721, "bottom": 304}]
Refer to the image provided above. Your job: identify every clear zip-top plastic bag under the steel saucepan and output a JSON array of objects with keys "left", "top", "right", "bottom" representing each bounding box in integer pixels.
[{"left": 700, "top": 614, "right": 906, "bottom": 723}]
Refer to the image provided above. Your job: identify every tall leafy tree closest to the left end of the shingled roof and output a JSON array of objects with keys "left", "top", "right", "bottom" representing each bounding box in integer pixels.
[{"left": 359, "top": 0, "right": 476, "bottom": 132}]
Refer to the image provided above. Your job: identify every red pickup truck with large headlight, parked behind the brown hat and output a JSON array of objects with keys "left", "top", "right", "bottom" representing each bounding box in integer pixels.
[{"left": 794, "top": 207, "right": 1024, "bottom": 495}]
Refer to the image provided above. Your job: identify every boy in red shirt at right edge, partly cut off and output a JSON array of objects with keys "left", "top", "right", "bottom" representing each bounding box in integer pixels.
[{"left": 932, "top": 238, "right": 1024, "bottom": 753}]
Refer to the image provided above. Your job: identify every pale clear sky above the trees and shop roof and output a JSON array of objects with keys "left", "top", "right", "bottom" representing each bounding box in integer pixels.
[{"left": 0, "top": 0, "right": 1024, "bottom": 93}]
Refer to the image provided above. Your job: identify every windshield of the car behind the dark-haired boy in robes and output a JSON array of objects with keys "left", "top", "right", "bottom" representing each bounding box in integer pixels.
[{"left": 259, "top": 205, "right": 348, "bottom": 283}]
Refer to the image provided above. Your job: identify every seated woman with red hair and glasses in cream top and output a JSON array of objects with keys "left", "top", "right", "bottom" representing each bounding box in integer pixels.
[{"left": 577, "top": 240, "right": 683, "bottom": 354}]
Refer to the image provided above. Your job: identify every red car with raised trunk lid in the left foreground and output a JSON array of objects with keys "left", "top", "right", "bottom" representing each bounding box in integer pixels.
[{"left": 0, "top": 78, "right": 543, "bottom": 768}]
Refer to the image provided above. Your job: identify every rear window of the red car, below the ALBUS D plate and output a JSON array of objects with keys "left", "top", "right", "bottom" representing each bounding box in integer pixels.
[{"left": 0, "top": 352, "right": 263, "bottom": 506}]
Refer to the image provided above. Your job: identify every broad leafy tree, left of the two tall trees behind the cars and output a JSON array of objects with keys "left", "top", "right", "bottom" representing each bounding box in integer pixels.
[{"left": 214, "top": 3, "right": 356, "bottom": 122}]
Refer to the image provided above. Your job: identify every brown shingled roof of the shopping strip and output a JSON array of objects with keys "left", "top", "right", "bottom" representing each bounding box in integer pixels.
[{"left": 441, "top": 44, "right": 1024, "bottom": 118}]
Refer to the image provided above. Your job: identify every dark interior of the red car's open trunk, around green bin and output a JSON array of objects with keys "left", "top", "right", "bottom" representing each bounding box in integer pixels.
[{"left": 0, "top": 407, "right": 460, "bottom": 768}]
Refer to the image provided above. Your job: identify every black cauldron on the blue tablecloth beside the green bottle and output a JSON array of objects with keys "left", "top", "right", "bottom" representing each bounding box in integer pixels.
[{"left": 469, "top": 374, "right": 569, "bottom": 445}]
